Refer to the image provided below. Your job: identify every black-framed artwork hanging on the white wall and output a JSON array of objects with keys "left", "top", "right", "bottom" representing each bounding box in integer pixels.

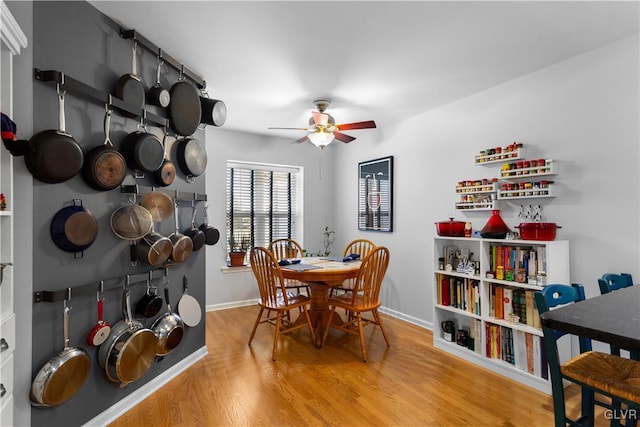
[{"left": 358, "top": 156, "right": 393, "bottom": 232}]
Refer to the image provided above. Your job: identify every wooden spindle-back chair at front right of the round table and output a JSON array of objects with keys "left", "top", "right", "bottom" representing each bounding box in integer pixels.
[{"left": 322, "top": 246, "right": 391, "bottom": 362}]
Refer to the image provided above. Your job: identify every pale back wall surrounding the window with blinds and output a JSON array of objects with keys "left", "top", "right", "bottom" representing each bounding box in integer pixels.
[{"left": 205, "top": 129, "right": 334, "bottom": 309}]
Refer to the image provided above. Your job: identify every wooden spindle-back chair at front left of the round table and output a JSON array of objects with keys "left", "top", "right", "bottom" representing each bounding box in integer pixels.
[{"left": 249, "top": 247, "right": 315, "bottom": 361}]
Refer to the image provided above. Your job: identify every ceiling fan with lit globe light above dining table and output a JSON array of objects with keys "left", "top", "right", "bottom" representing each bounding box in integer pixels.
[{"left": 268, "top": 99, "right": 376, "bottom": 148}]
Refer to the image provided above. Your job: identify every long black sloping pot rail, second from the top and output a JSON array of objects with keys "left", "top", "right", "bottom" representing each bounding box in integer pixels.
[{"left": 33, "top": 68, "right": 169, "bottom": 128}]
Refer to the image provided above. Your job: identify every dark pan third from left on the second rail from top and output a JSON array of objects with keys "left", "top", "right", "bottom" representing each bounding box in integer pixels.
[{"left": 122, "top": 118, "right": 164, "bottom": 173}]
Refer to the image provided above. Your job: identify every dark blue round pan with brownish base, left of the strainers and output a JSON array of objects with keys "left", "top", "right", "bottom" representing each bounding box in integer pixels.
[{"left": 50, "top": 199, "right": 98, "bottom": 257}]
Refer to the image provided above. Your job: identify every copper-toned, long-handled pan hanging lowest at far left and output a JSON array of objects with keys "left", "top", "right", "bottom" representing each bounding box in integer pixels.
[{"left": 30, "top": 289, "right": 91, "bottom": 406}]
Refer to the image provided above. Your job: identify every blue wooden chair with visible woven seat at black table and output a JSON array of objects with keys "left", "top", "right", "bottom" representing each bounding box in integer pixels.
[{"left": 534, "top": 284, "right": 640, "bottom": 427}]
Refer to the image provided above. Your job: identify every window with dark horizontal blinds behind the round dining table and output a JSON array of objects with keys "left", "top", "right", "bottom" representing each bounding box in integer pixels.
[{"left": 226, "top": 162, "right": 303, "bottom": 258}]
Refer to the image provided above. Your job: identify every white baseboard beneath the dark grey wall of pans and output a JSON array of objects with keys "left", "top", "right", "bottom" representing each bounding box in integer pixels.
[{"left": 84, "top": 346, "right": 208, "bottom": 427}]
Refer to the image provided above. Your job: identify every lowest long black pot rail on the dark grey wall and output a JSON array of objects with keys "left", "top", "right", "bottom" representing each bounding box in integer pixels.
[{"left": 33, "top": 267, "right": 165, "bottom": 303}]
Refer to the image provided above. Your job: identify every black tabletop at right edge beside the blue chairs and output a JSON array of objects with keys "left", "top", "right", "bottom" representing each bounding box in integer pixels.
[{"left": 540, "top": 285, "right": 640, "bottom": 352}]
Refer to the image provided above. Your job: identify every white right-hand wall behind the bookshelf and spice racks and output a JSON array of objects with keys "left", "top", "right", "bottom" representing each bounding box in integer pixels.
[{"left": 334, "top": 36, "right": 640, "bottom": 325}]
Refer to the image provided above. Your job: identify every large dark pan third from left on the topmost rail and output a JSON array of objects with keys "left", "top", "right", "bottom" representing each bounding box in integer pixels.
[{"left": 168, "top": 73, "right": 202, "bottom": 136}]
